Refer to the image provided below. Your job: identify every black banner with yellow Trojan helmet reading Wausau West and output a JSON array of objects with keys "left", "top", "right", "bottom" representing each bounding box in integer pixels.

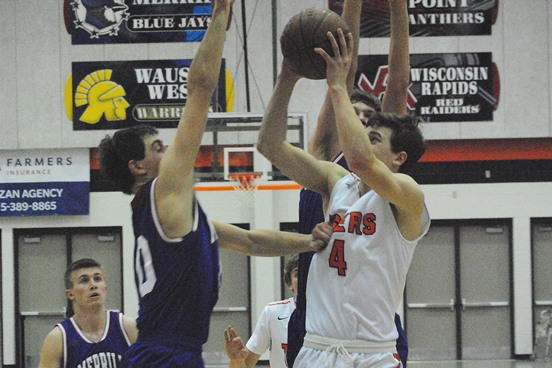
[{"left": 70, "top": 59, "right": 226, "bottom": 130}]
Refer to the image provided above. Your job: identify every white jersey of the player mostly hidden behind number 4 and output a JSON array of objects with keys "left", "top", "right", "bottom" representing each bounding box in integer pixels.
[{"left": 246, "top": 298, "right": 295, "bottom": 368}]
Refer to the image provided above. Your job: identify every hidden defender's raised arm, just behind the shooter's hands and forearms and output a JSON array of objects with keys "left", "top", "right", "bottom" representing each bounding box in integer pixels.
[{"left": 309, "top": 0, "right": 362, "bottom": 161}]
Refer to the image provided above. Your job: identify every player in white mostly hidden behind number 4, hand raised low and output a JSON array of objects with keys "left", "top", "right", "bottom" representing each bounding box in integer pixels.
[{"left": 224, "top": 255, "right": 299, "bottom": 368}]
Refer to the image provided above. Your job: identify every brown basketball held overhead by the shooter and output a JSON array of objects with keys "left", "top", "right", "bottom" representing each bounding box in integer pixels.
[{"left": 280, "top": 8, "right": 349, "bottom": 79}]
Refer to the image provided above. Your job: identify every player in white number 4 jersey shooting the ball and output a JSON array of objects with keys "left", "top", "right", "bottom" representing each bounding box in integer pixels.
[{"left": 257, "top": 30, "right": 430, "bottom": 368}]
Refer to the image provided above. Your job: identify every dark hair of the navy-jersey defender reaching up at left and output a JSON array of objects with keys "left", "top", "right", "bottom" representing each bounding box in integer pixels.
[{"left": 99, "top": 124, "right": 158, "bottom": 194}]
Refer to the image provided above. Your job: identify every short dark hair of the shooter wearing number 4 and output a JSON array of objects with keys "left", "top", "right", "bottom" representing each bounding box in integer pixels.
[{"left": 368, "top": 112, "right": 426, "bottom": 173}]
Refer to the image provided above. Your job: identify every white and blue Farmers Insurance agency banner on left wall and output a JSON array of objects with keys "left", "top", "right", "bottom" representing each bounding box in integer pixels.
[{"left": 0, "top": 148, "right": 90, "bottom": 217}]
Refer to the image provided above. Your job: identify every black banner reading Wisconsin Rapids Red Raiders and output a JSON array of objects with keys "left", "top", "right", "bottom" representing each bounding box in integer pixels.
[{"left": 356, "top": 52, "right": 500, "bottom": 122}]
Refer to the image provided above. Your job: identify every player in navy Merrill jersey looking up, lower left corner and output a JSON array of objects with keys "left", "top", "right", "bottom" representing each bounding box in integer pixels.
[{"left": 38, "top": 258, "right": 138, "bottom": 368}]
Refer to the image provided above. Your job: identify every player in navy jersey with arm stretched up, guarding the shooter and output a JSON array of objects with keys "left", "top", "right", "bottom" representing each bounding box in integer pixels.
[{"left": 100, "top": 0, "right": 331, "bottom": 368}]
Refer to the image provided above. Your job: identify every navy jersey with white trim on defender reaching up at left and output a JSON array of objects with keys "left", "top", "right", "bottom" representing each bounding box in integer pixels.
[{"left": 132, "top": 179, "right": 220, "bottom": 353}]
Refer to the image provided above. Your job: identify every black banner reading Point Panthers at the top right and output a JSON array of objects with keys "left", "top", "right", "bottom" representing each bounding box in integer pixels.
[{"left": 329, "top": 0, "right": 498, "bottom": 37}]
